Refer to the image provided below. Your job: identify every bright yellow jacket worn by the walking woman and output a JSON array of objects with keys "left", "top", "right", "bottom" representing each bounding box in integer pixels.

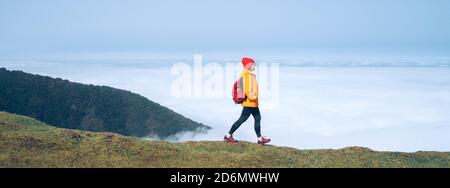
[{"left": 240, "top": 69, "right": 258, "bottom": 107}]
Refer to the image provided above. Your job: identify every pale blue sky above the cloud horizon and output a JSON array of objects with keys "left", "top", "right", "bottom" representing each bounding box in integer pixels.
[{"left": 0, "top": 0, "right": 450, "bottom": 57}]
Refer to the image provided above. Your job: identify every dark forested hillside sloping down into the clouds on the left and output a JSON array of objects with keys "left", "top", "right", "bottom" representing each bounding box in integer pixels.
[{"left": 0, "top": 68, "right": 209, "bottom": 137}]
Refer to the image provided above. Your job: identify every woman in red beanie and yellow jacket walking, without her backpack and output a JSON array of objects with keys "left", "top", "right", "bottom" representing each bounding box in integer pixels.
[{"left": 224, "top": 57, "right": 270, "bottom": 144}]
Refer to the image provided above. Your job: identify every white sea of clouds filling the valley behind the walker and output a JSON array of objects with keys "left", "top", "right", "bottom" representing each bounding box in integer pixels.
[{"left": 0, "top": 59, "right": 450, "bottom": 152}]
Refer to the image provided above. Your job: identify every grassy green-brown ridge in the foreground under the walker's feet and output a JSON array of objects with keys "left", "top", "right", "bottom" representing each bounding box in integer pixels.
[{"left": 0, "top": 112, "right": 450, "bottom": 167}]
